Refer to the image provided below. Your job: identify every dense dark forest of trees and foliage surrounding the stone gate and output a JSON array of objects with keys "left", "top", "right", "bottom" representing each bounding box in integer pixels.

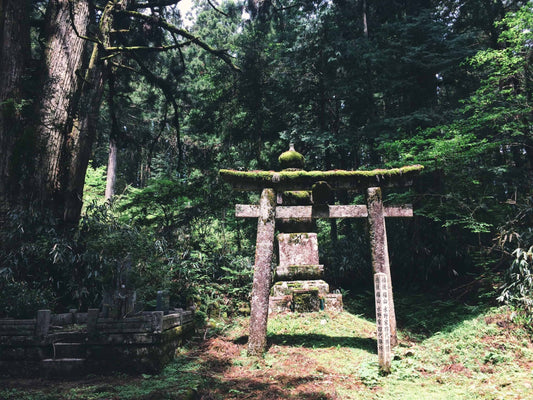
[{"left": 0, "top": 0, "right": 533, "bottom": 316}]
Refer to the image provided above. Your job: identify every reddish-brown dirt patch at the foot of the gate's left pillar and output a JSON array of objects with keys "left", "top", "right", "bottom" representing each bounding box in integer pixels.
[{"left": 190, "top": 338, "right": 363, "bottom": 400}]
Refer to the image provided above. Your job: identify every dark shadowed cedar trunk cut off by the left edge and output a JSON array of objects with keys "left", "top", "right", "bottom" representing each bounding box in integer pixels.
[{"left": 0, "top": 0, "right": 30, "bottom": 217}]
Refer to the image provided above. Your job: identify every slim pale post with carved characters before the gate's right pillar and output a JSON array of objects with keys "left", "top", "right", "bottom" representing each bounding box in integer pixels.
[{"left": 374, "top": 272, "right": 392, "bottom": 373}]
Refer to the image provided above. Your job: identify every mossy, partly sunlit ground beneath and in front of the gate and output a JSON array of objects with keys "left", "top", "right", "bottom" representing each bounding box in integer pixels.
[{"left": 0, "top": 296, "right": 533, "bottom": 400}]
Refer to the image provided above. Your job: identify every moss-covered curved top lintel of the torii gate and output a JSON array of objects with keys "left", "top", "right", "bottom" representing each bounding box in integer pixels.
[{"left": 220, "top": 165, "right": 424, "bottom": 191}]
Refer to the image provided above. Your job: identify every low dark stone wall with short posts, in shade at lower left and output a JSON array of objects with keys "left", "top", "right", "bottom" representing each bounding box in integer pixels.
[{"left": 0, "top": 309, "right": 194, "bottom": 378}]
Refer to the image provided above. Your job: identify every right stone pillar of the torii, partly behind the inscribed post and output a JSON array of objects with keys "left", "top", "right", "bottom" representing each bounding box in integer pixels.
[{"left": 366, "top": 187, "right": 398, "bottom": 346}]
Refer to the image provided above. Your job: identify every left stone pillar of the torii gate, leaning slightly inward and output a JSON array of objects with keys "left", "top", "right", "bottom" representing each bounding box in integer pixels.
[{"left": 248, "top": 189, "right": 276, "bottom": 355}]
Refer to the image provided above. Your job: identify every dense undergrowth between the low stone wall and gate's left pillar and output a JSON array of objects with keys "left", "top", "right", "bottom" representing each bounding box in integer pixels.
[{"left": 0, "top": 192, "right": 253, "bottom": 319}]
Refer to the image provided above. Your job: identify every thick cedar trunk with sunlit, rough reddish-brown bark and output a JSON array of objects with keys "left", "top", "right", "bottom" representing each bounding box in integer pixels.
[{"left": 34, "top": 0, "right": 89, "bottom": 217}]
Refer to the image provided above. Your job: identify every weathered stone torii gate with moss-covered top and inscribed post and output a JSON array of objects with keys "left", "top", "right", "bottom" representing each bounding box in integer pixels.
[{"left": 220, "top": 145, "right": 423, "bottom": 371}]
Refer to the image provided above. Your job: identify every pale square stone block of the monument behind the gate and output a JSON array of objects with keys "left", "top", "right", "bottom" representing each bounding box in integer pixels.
[{"left": 278, "top": 233, "right": 320, "bottom": 267}]
